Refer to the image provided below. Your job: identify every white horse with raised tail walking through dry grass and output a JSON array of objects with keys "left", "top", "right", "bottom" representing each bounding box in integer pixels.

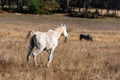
[{"left": 25, "top": 24, "right": 68, "bottom": 67}]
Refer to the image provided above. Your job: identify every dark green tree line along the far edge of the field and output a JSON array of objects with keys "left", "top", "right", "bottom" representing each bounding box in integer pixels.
[{"left": 0, "top": 0, "right": 120, "bottom": 17}]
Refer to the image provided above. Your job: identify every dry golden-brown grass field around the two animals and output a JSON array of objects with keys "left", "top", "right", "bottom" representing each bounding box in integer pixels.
[{"left": 0, "top": 13, "right": 120, "bottom": 80}]
